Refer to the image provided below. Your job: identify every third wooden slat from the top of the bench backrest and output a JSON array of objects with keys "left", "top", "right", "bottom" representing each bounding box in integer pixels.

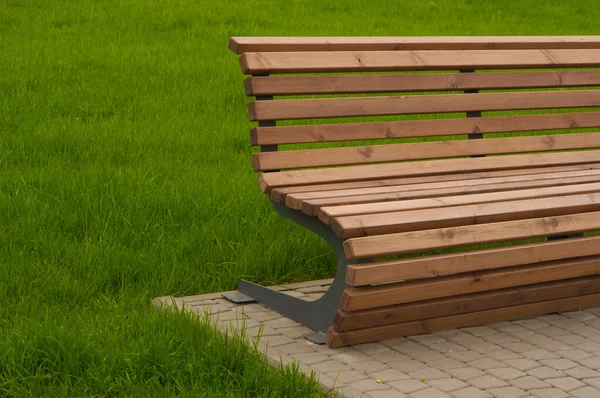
[{"left": 244, "top": 70, "right": 600, "bottom": 96}]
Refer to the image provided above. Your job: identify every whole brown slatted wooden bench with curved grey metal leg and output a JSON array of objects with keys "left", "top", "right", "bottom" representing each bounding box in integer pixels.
[{"left": 229, "top": 36, "right": 600, "bottom": 347}]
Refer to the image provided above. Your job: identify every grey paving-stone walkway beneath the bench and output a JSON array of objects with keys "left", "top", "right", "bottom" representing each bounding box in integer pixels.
[{"left": 155, "top": 279, "right": 600, "bottom": 398}]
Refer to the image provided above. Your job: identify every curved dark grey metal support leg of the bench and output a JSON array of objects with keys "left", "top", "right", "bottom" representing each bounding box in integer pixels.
[{"left": 238, "top": 202, "right": 366, "bottom": 333}]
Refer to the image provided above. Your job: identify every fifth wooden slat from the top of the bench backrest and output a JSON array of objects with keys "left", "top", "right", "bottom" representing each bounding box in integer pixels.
[{"left": 250, "top": 112, "right": 600, "bottom": 145}]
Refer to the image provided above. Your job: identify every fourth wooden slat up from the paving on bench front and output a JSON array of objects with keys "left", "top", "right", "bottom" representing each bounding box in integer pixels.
[{"left": 346, "top": 236, "right": 600, "bottom": 287}]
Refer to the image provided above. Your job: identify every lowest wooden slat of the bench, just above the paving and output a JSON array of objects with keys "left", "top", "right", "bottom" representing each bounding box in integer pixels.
[{"left": 325, "top": 294, "right": 600, "bottom": 348}]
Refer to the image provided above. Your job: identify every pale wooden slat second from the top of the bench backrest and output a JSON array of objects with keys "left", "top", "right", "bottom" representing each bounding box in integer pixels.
[{"left": 240, "top": 49, "right": 600, "bottom": 74}]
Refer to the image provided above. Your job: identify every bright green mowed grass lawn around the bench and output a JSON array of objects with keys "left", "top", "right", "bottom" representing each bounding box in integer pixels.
[{"left": 0, "top": 0, "right": 600, "bottom": 397}]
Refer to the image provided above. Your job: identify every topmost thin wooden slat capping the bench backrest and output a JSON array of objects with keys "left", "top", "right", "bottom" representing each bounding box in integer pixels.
[{"left": 229, "top": 36, "right": 600, "bottom": 54}]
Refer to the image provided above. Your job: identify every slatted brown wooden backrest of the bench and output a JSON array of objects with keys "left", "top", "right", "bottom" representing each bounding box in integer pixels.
[{"left": 230, "top": 36, "right": 600, "bottom": 171}]
